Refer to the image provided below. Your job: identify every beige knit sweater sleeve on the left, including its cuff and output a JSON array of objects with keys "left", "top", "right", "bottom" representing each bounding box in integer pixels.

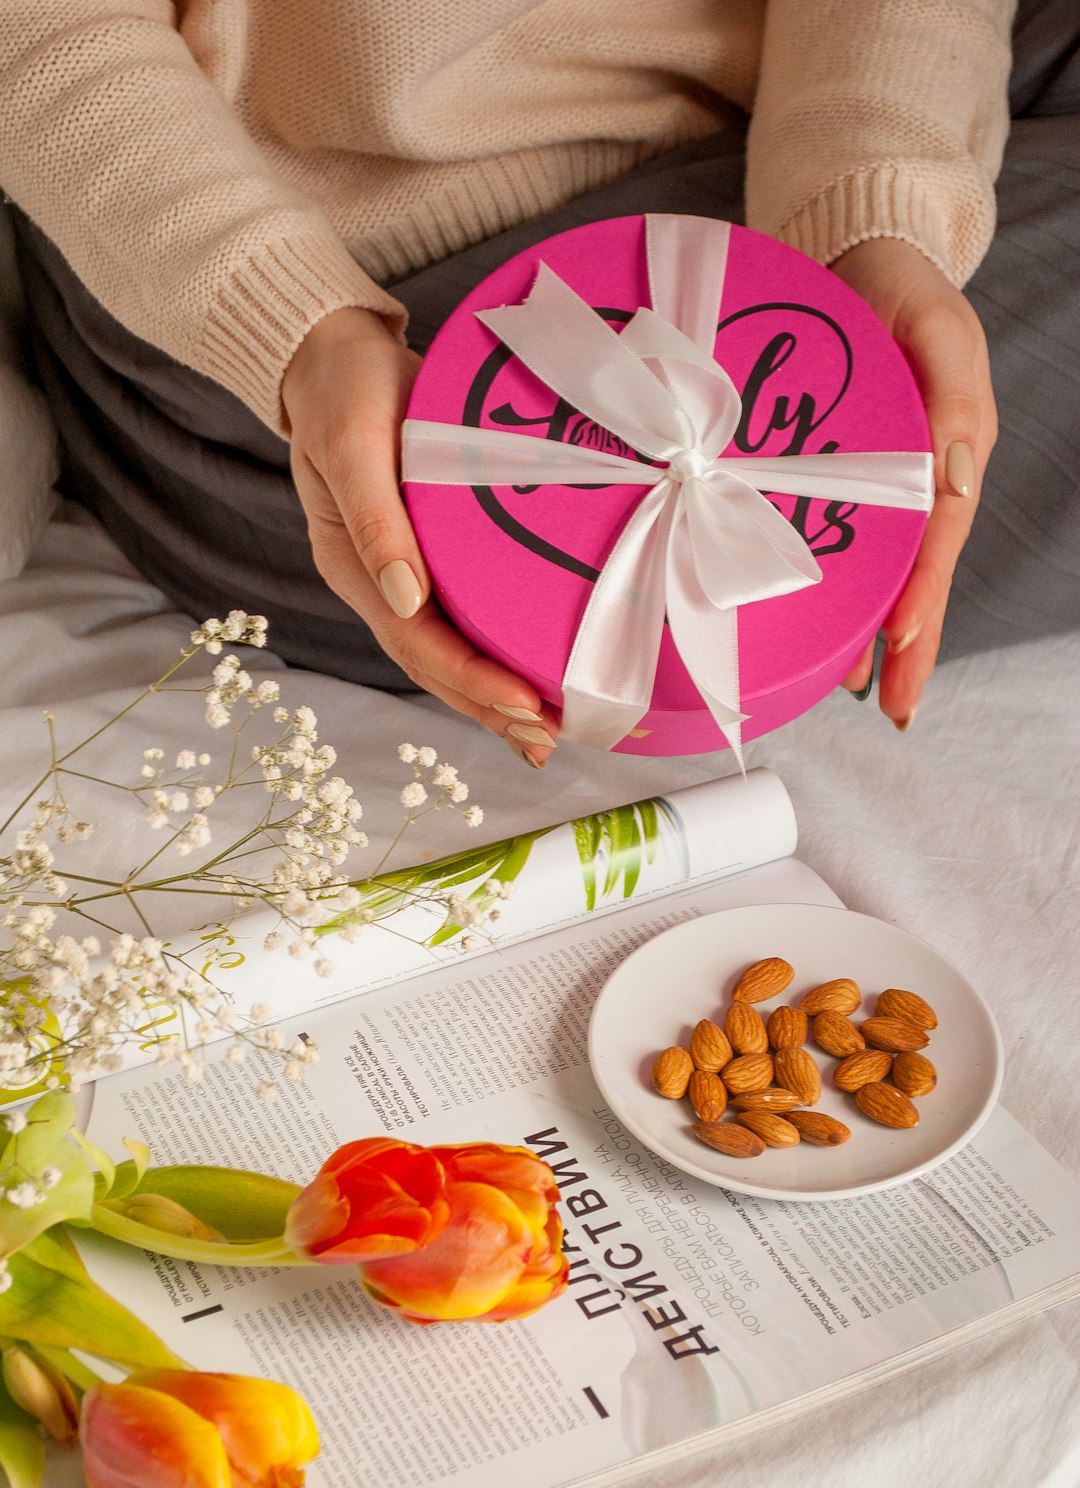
[{"left": 0, "top": 0, "right": 405, "bottom": 432}]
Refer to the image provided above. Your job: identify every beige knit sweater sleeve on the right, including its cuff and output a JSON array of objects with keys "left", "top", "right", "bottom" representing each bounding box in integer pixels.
[{"left": 747, "top": 0, "right": 1015, "bottom": 284}]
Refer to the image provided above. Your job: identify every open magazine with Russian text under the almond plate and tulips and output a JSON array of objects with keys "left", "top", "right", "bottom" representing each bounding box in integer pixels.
[{"left": 69, "top": 771, "right": 1080, "bottom": 1488}]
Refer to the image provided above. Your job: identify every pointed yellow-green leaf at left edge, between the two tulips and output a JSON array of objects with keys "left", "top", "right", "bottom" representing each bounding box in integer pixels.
[{"left": 0, "top": 1251, "right": 184, "bottom": 1369}]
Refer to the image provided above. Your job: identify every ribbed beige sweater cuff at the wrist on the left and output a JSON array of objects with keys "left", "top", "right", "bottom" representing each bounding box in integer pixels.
[{"left": 198, "top": 232, "right": 406, "bottom": 437}]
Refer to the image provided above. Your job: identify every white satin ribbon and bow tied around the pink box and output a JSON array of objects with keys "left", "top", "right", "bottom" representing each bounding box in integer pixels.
[{"left": 402, "top": 216, "right": 934, "bottom": 766}]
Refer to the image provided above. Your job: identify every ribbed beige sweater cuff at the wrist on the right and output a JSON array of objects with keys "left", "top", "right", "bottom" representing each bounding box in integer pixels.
[{"left": 774, "top": 165, "right": 977, "bottom": 284}]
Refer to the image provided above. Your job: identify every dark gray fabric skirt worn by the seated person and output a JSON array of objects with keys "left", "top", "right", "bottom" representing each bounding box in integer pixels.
[{"left": 8, "top": 0, "right": 1080, "bottom": 689}]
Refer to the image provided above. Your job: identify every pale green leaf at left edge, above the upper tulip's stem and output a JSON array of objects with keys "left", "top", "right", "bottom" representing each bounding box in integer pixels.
[{"left": 0, "top": 1091, "right": 94, "bottom": 1256}]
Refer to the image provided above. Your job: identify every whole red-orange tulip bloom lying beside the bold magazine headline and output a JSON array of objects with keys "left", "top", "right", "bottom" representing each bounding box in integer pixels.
[{"left": 286, "top": 1138, "right": 567, "bottom": 1323}]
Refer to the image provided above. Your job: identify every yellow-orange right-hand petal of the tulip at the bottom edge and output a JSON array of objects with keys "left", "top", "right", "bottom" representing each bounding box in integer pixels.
[{"left": 132, "top": 1369, "right": 318, "bottom": 1488}]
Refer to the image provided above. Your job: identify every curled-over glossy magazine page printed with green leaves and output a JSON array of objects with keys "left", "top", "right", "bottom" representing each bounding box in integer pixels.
[{"left": 8, "top": 769, "right": 803, "bottom": 1106}]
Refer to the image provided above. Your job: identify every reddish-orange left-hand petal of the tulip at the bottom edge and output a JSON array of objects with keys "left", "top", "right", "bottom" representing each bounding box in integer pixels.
[{"left": 79, "top": 1384, "right": 232, "bottom": 1488}]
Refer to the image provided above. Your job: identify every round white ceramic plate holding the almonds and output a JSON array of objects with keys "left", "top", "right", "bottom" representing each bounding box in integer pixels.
[{"left": 589, "top": 905, "right": 1003, "bottom": 1199}]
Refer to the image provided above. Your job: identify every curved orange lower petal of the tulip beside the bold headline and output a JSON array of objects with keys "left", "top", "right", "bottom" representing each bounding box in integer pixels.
[{"left": 360, "top": 1183, "right": 533, "bottom": 1321}]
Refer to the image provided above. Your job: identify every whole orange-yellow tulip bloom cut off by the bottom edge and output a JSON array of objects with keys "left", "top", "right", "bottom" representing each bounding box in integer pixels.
[{"left": 79, "top": 1369, "right": 318, "bottom": 1488}]
